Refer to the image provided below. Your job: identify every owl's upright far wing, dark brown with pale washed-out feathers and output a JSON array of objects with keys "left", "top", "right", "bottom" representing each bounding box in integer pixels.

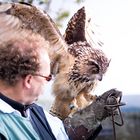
[{"left": 64, "top": 7, "right": 103, "bottom": 48}]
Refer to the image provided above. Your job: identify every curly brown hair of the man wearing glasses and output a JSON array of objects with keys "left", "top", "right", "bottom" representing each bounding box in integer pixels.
[{"left": 0, "top": 35, "right": 48, "bottom": 86}]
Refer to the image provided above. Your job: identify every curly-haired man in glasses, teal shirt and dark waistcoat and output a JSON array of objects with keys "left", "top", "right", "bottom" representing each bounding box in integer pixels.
[{"left": 0, "top": 32, "right": 68, "bottom": 140}]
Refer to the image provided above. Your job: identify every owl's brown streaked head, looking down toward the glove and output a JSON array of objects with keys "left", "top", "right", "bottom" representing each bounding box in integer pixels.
[{"left": 68, "top": 41, "right": 110, "bottom": 82}]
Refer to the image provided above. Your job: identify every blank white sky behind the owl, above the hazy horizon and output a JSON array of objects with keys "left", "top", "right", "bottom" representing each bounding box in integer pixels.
[{"left": 47, "top": 0, "right": 140, "bottom": 95}]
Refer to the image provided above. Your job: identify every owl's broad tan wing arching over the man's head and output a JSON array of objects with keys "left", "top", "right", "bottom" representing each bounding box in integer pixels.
[{"left": 0, "top": 3, "right": 67, "bottom": 74}]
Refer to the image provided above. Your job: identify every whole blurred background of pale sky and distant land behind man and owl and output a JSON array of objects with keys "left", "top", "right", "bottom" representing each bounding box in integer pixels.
[{"left": 0, "top": 0, "right": 140, "bottom": 140}]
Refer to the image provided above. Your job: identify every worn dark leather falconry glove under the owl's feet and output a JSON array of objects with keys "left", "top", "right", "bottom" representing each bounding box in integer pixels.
[{"left": 64, "top": 89, "right": 122, "bottom": 140}]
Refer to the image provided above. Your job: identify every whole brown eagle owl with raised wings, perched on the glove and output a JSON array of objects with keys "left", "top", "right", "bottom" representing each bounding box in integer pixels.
[{"left": 0, "top": 3, "right": 109, "bottom": 119}]
